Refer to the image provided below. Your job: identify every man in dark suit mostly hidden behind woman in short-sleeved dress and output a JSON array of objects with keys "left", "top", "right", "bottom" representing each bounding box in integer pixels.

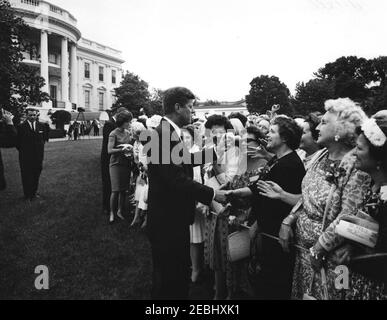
[{"left": 101, "top": 107, "right": 128, "bottom": 215}]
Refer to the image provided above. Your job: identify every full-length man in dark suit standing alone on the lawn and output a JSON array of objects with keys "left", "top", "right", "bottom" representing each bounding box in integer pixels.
[{"left": 16, "top": 108, "right": 47, "bottom": 200}]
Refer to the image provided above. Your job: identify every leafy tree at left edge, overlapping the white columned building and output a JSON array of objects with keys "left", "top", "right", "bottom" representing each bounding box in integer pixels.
[{"left": 0, "top": 0, "right": 49, "bottom": 117}]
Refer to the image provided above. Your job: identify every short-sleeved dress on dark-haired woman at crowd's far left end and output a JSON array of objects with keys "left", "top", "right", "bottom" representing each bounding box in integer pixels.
[{"left": 109, "top": 128, "right": 131, "bottom": 192}]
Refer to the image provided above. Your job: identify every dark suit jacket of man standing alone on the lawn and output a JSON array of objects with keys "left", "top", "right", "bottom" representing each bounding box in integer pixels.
[{"left": 16, "top": 121, "right": 47, "bottom": 168}]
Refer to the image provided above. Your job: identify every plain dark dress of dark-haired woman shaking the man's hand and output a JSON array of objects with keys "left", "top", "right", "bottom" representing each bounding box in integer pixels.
[{"left": 249, "top": 152, "right": 305, "bottom": 299}]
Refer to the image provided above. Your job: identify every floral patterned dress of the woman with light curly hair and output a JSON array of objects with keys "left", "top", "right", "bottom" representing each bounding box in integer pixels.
[{"left": 292, "top": 149, "right": 370, "bottom": 299}]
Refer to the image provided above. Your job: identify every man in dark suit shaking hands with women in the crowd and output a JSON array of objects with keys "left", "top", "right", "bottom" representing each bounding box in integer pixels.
[{"left": 146, "top": 87, "right": 229, "bottom": 299}]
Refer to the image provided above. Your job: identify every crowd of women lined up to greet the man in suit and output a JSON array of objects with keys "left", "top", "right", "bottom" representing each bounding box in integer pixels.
[{"left": 108, "top": 98, "right": 387, "bottom": 299}]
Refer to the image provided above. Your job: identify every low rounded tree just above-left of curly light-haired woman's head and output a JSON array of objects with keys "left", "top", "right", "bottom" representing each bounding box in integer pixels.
[{"left": 292, "top": 79, "right": 335, "bottom": 115}]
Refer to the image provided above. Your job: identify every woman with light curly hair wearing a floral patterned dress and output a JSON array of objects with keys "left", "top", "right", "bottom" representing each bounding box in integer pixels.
[{"left": 280, "top": 98, "right": 370, "bottom": 299}]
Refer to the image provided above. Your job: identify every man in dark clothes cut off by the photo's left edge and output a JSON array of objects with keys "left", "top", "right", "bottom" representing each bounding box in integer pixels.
[{"left": 0, "top": 109, "right": 17, "bottom": 191}]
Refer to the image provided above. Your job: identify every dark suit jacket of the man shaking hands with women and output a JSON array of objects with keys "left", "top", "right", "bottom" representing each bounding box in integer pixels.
[{"left": 147, "top": 119, "right": 216, "bottom": 249}]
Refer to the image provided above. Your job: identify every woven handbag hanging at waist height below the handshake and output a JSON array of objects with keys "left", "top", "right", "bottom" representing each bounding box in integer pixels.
[{"left": 227, "top": 229, "right": 250, "bottom": 262}]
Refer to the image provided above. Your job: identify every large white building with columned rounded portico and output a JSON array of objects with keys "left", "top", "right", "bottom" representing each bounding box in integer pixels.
[{"left": 10, "top": 0, "right": 124, "bottom": 116}]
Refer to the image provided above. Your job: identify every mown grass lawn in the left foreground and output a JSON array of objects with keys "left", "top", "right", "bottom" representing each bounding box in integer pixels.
[{"left": 0, "top": 140, "right": 152, "bottom": 299}]
